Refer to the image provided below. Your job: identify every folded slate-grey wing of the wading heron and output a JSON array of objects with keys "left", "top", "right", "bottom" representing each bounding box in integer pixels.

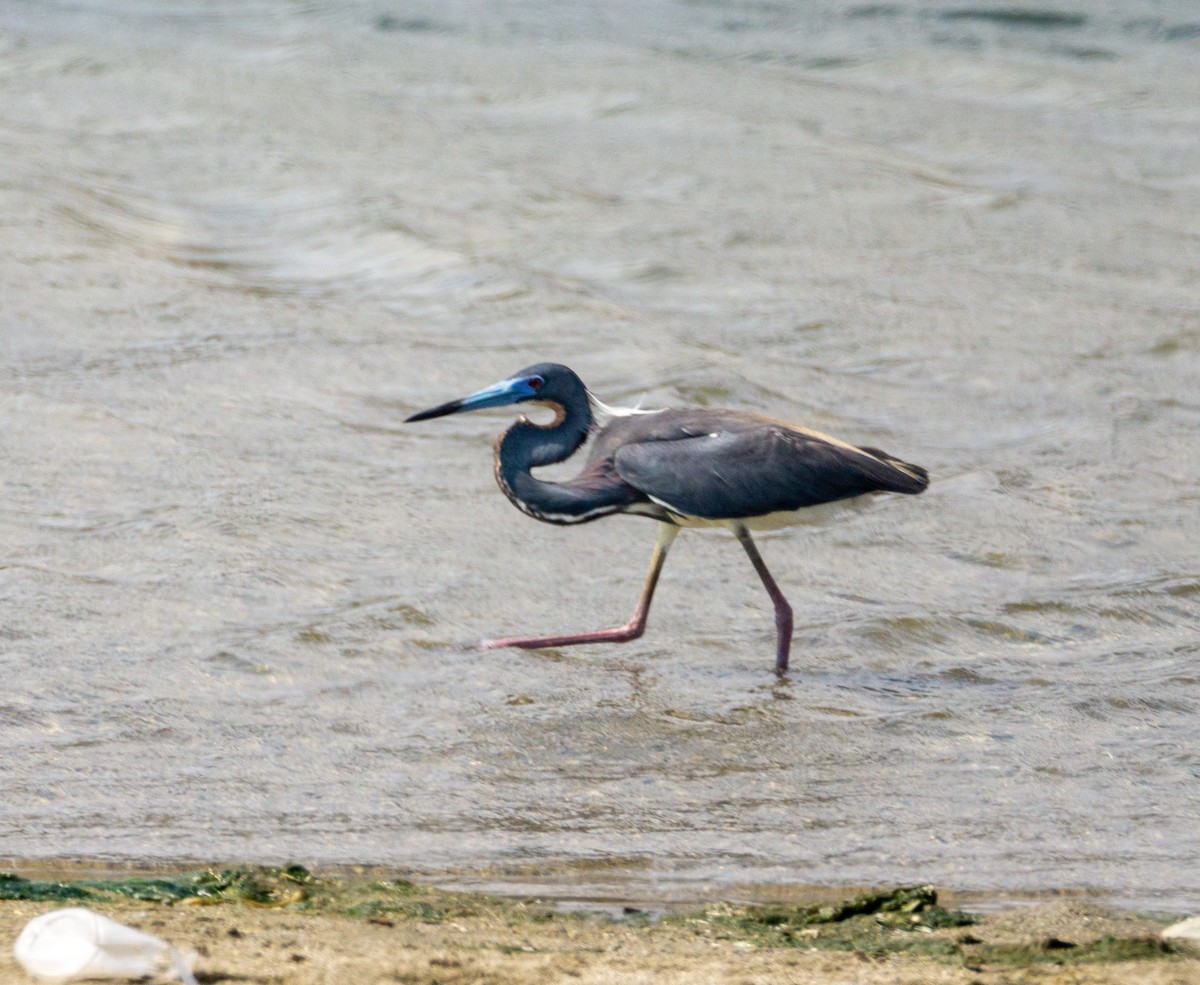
[{"left": 613, "top": 424, "right": 928, "bottom": 519}]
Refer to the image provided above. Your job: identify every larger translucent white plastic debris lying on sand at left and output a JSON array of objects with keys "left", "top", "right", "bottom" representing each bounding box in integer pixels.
[{"left": 13, "top": 907, "right": 197, "bottom": 985}]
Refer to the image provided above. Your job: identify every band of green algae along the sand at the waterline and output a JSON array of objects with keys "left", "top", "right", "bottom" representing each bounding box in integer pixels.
[{"left": 0, "top": 865, "right": 1181, "bottom": 967}]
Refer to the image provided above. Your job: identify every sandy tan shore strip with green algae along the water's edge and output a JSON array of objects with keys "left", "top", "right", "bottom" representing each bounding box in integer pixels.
[{"left": 0, "top": 879, "right": 1200, "bottom": 985}]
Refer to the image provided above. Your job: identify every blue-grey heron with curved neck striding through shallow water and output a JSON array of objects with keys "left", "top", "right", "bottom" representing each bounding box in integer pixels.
[{"left": 408, "top": 362, "right": 929, "bottom": 673}]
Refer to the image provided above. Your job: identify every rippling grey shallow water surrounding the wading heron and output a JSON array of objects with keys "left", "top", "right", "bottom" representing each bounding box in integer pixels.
[{"left": 0, "top": 0, "right": 1200, "bottom": 909}]
